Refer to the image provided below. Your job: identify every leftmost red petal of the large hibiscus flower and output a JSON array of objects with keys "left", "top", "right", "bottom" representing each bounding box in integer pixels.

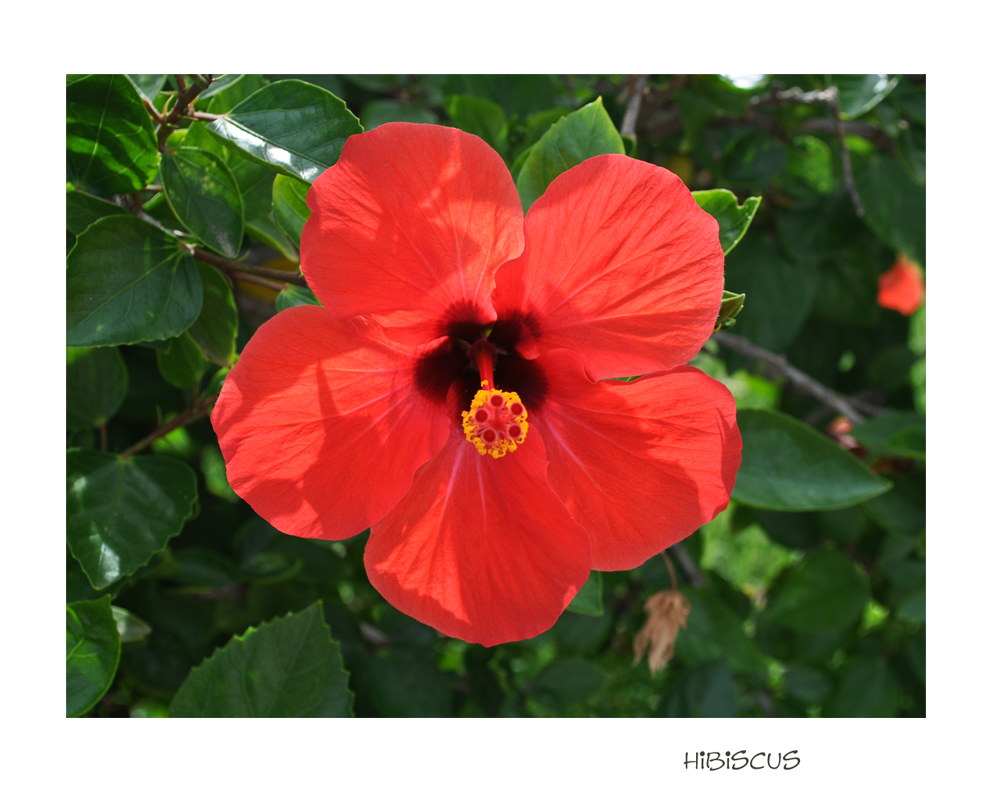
[{"left": 212, "top": 306, "right": 454, "bottom": 539}]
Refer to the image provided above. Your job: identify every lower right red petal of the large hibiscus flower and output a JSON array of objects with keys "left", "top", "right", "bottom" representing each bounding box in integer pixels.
[{"left": 532, "top": 350, "right": 742, "bottom": 570}]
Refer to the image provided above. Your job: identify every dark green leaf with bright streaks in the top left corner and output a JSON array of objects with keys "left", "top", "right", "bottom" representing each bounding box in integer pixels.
[{"left": 66, "top": 75, "right": 159, "bottom": 197}]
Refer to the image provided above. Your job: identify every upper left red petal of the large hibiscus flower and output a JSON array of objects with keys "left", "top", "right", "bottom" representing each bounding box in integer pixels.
[{"left": 302, "top": 122, "right": 524, "bottom": 342}]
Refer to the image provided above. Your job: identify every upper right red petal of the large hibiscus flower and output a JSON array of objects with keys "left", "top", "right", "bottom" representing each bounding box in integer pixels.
[{"left": 493, "top": 155, "right": 723, "bottom": 379}]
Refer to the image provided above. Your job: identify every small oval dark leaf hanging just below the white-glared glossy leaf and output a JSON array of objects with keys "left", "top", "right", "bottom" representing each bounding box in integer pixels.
[{"left": 160, "top": 147, "right": 243, "bottom": 258}]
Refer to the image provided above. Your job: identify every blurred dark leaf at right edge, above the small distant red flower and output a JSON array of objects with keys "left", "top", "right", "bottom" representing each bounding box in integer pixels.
[{"left": 854, "top": 154, "right": 927, "bottom": 266}]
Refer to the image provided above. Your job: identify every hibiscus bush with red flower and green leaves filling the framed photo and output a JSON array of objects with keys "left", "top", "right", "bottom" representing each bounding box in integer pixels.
[{"left": 66, "top": 75, "right": 926, "bottom": 717}]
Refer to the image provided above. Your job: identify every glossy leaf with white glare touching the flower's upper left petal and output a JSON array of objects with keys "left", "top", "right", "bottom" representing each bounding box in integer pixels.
[{"left": 208, "top": 80, "right": 362, "bottom": 183}]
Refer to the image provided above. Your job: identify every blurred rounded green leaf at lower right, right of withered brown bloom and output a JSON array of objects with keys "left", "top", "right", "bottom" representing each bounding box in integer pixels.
[{"left": 767, "top": 549, "right": 869, "bottom": 633}]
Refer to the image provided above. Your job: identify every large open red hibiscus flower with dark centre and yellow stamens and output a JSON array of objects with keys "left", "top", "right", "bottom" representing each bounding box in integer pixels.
[{"left": 212, "top": 123, "right": 741, "bottom": 645}]
